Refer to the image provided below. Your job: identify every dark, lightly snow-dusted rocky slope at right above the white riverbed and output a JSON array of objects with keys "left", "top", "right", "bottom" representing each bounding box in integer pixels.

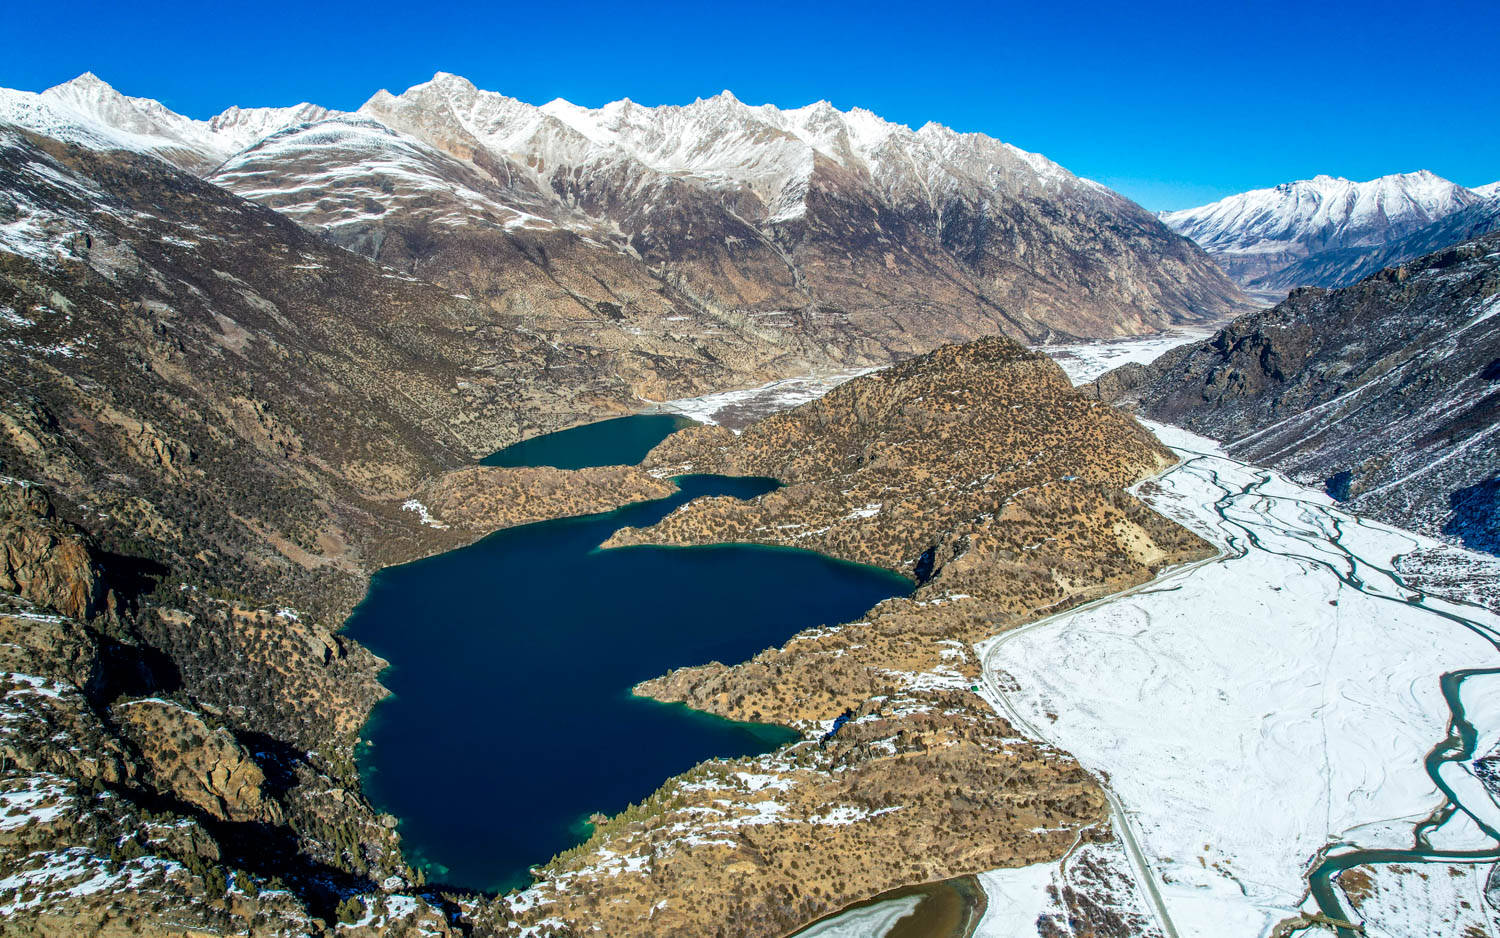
[{"left": 1092, "top": 234, "right": 1500, "bottom": 551}]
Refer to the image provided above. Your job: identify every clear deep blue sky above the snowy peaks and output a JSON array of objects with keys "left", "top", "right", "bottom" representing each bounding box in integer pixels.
[{"left": 0, "top": 0, "right": 1500, "bottom": 209}]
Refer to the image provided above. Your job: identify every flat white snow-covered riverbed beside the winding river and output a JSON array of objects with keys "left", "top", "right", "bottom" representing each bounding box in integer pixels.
[{"left": 980, "top": 428, "right": 1500, "bottom": 938}]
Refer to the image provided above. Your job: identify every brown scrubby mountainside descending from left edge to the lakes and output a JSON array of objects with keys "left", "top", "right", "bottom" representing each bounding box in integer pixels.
[{"left": 0, "top": 124, "right": 675, "bottom": 621}]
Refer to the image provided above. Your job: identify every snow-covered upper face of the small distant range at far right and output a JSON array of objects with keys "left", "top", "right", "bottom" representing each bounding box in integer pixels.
[{"left": 1161, "top": 170, "right": 1485, "bottom": 290}]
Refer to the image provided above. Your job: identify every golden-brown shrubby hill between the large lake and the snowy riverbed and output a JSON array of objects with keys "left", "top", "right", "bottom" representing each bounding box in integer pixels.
[{"left": 476, "top": 339, "right": 1209, "bottom": 935}]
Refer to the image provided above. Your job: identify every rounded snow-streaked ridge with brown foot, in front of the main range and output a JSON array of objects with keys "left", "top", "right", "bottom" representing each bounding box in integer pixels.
[{"left": 210, "top": 117, "right": 905, "bottom": 399}]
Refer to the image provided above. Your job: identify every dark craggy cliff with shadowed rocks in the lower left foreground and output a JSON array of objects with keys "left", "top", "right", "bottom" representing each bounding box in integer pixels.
[{"left": 0, "top": 480, "right": 462, "bottom": 935}]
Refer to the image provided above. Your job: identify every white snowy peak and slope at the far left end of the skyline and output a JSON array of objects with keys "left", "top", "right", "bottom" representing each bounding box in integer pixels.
[{"left": 0, "top": 72, "right": 330, "bottom": 173}]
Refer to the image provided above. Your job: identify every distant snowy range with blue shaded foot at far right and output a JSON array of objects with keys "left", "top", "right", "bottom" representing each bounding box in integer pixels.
[{"left": 1161, "top": 170, "right": 1500, "bottom": 293}]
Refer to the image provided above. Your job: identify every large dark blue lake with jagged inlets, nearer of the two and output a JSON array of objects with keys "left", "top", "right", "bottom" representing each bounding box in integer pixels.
[{"left": 347, "top": 422, "right": 912, "bottom": 890}]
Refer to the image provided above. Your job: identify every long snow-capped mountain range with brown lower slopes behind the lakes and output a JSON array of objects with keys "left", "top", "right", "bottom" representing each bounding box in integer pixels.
[{"left": 0, "top": 74, "right": 1247, "bottom": 343}]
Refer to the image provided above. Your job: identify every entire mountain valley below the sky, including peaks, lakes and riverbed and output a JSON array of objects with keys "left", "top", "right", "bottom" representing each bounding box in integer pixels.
[{"left": 0, "top": 66, "right": 1500, "bottom": 938}]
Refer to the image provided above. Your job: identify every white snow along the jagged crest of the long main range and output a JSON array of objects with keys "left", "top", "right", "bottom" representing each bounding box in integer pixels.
[{"left": 0, "top": 72, "right": 1107, "bottom": 224}]
